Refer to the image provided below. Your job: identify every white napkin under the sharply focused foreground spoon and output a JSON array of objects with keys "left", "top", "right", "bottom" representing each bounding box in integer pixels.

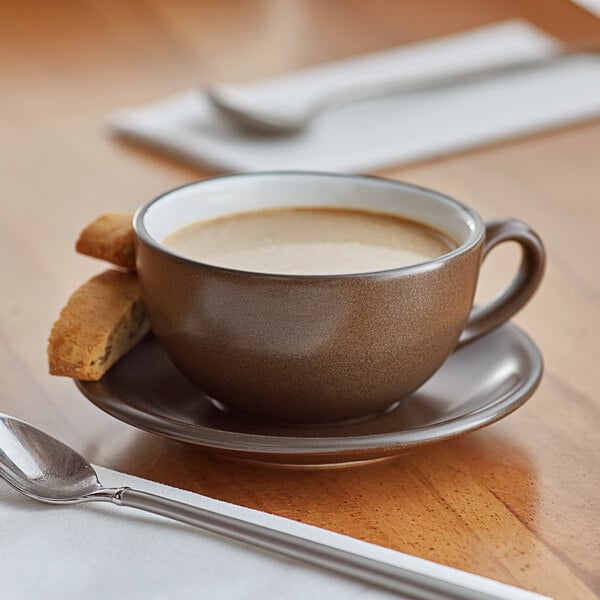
[{"left": 0, "top": 467, "right": 544, "bottom": 600}]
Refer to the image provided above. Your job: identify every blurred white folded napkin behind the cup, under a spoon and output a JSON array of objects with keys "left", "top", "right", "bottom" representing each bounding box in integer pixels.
[{"left": 110, "top": 21, "right": 600, "bottom": 171}]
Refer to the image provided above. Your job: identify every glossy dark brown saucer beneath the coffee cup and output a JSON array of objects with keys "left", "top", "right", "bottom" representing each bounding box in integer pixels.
[{"left": 76, "top": 324, "right": 542, "bottom": 466}]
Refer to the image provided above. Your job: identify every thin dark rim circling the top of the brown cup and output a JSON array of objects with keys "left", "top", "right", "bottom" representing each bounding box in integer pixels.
[{"left": 133, "top": 169, "right": 485, "bottom": 280}]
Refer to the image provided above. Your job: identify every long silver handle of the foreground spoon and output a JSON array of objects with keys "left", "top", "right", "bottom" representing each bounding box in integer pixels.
[{"left": 113, "top": 488, "right": 500, "bottom": 600}]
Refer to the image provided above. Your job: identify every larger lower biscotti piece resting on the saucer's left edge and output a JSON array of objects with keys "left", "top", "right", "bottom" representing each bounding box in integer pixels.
[{"left": 48, "top": 269, "right": 150, "bottom": 381}]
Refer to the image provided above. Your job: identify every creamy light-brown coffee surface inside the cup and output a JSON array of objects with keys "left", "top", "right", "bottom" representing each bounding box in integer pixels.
[{"left": 163, "top": 208, "right": 456, "bottom": 275}]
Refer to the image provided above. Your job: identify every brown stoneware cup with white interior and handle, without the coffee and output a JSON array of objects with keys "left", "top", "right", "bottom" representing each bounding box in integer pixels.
[{"left": 134, "top": 172, "right": 545, "bottom": 423}]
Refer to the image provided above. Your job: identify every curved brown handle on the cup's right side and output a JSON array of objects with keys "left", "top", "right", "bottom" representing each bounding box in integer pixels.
[{"left": 456, "top": 219, "right": 546, "bottom": 348}]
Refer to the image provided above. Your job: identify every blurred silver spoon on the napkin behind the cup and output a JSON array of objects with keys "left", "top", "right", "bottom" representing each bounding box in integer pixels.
[{"left": 204, "top": 38, "right": 600, "bottom": 135}]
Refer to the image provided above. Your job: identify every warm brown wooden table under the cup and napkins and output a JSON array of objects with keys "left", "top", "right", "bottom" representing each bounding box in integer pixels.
[{"left": 0, "top": 0, "right": 600, "bottom": 599}]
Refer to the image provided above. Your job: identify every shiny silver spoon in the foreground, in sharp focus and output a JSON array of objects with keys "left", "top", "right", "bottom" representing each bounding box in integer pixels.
[{"left": 0, "top": 413, "right": 506, "bottom": 600}]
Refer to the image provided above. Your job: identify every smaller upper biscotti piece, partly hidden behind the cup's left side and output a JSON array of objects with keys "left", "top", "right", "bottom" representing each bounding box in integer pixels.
[{"left": 75, "top": 212, "right": 135, "bottom": 271}]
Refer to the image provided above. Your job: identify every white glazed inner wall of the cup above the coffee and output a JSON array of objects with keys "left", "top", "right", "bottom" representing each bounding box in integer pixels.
[{"left": 135, "top": 172, "right": 483, "bottom": 258}]
